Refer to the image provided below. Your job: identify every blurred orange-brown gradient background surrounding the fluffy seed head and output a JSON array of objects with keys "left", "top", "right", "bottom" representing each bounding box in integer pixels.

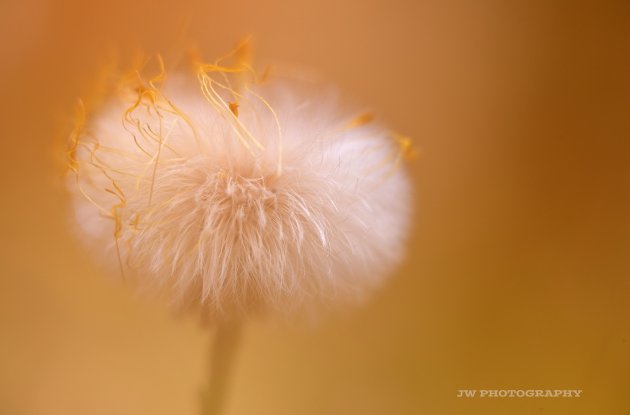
[{"left": 0, "top": 0, "right": 630, "bottom": 415}]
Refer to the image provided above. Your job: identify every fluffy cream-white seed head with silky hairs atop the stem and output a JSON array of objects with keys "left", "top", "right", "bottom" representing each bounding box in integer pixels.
[{"left": 69, "top": 70, "right": 410, "bottom": 316}]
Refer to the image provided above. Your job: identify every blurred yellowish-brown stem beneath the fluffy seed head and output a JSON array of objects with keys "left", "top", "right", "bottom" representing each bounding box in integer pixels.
[{"left": 201, "top": 322, "right": 240, "bottom": 415}]
